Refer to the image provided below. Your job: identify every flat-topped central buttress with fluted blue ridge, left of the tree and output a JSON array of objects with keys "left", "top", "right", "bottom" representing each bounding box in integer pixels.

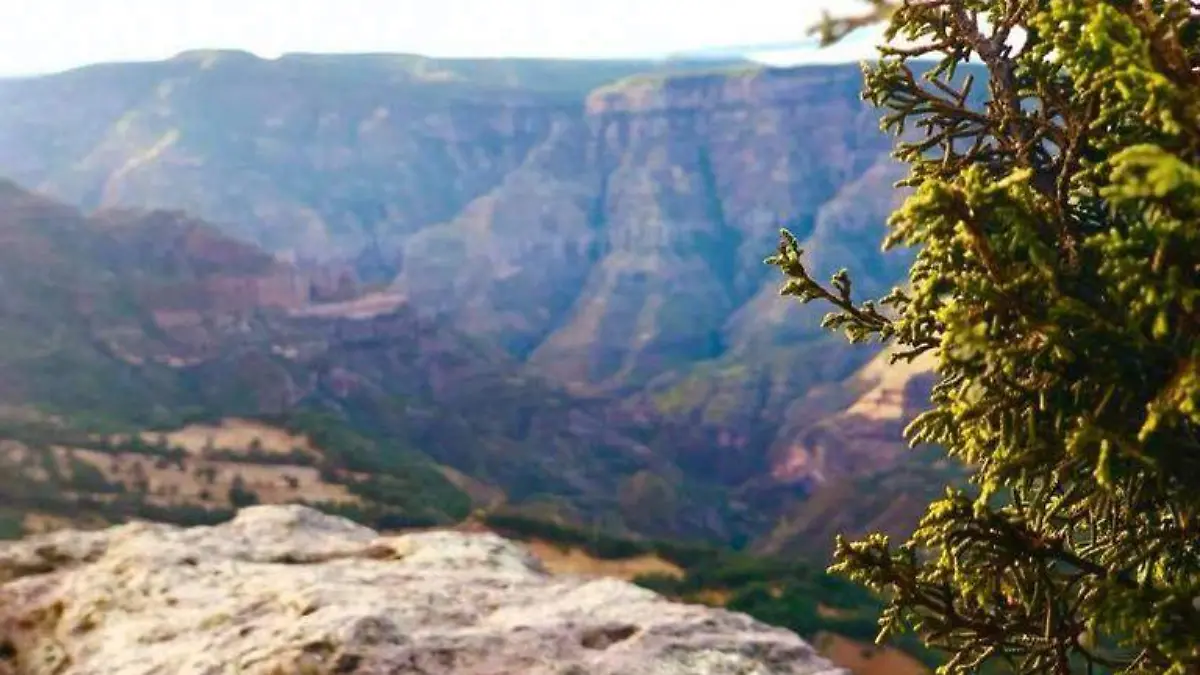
[{"left": 533, "top": 67, "right": 889, "bottom": 383}]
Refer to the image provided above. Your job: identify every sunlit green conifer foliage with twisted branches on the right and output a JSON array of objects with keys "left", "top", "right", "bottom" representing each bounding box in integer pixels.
[{"left": 768, "top": 0, "right": 1200, "bottom": 675}]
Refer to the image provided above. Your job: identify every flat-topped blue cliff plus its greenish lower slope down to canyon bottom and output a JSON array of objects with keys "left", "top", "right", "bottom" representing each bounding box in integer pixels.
[{"left": 394, "top": 67, "right": 907, "bottom": 499}]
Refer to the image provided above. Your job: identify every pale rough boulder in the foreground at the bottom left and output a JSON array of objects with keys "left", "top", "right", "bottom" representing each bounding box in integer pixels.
[{"left": 0, "top": 506, "right": 845, "bottom": 675}]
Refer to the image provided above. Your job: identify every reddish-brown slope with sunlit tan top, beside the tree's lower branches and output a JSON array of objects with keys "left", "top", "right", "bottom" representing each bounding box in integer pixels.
[{"left": 755, "top": 353, "right": 967, "bottom": 557}]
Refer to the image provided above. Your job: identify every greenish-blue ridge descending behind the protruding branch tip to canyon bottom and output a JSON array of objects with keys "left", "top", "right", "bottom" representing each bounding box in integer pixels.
[{"left": 604, "top": 154, "right": 905, "bottom": 492}]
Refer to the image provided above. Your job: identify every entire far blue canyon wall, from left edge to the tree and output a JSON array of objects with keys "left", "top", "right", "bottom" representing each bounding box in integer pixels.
[{"left": 0, "top": 53, "right": 895, "bottom": 388}]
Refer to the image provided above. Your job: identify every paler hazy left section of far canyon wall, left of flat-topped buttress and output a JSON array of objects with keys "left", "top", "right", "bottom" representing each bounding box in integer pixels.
[{"left": 0, "top": 52, "right": 729, "bottom": 265}]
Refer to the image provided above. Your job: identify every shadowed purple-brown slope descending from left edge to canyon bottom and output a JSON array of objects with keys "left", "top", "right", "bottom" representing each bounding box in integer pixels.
[{"left": 0, "top": 184, "right": 768, "bottom": 538}]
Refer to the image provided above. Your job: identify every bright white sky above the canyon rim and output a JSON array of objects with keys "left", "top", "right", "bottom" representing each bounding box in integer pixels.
[{"left": 0, "top": 0, "right": 872, "bottom": 74}]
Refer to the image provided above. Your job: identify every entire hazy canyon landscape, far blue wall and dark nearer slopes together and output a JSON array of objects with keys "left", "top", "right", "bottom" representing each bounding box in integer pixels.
[{"left": 0, "top": 52, "right": 960, "bottom": 550}]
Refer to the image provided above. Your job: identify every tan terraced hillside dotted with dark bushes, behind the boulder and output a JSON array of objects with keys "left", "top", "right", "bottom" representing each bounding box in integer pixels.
[{"left": 0, "top": 414, "right": 472, "bottom": 534}]
